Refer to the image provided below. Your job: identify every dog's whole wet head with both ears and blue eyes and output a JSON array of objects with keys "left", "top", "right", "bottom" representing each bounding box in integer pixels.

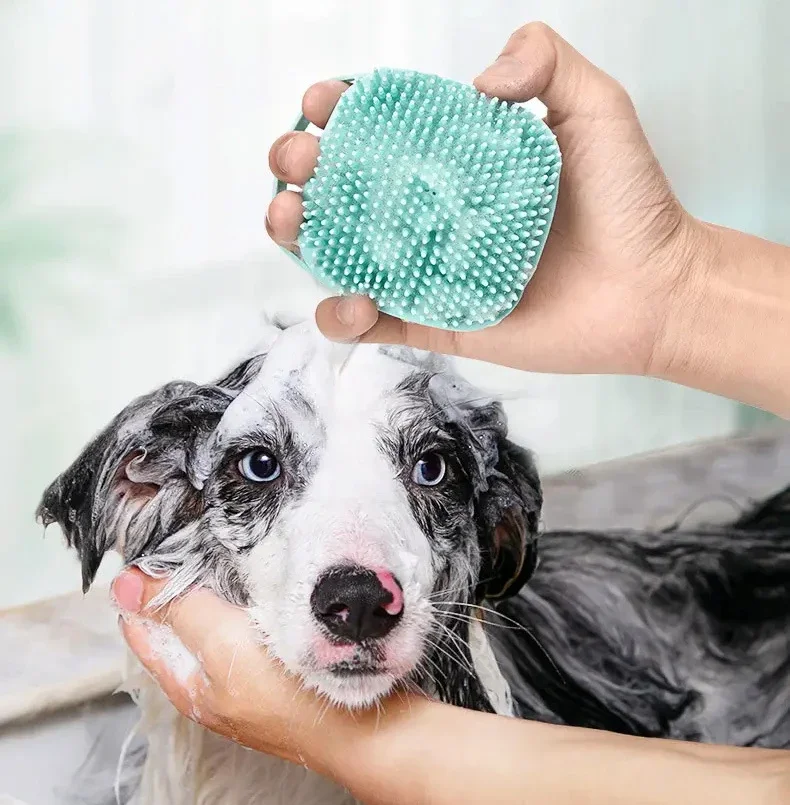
[{"left": 40, "top": 324, "right": 540, "bottom": 709}]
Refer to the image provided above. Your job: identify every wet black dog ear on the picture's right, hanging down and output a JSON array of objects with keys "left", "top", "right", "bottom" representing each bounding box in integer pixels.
[{"left": 477, "top": 437, "right": 543, "bottom": 599}]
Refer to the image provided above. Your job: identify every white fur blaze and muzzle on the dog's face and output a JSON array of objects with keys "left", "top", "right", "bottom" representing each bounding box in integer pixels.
[{"left": 205, "top": 323, "right": 442, "bottom": 707}]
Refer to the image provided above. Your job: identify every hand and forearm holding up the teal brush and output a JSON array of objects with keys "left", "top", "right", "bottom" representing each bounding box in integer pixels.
[{"left": 267, "top": 23, "right": 790, "bottom": 416}]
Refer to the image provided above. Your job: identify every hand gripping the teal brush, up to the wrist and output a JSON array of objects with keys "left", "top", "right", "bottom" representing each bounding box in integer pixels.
[{"left": 267, "top": 23, "right": 705, "bottom": 374}]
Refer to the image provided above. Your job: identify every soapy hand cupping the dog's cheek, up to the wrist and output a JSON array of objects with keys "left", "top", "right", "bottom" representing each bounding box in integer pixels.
[{"left": 112, "top": 569, "right": 365, "bottom": 770}]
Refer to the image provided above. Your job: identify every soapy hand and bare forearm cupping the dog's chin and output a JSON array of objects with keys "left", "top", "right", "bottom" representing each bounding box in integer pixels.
[{"left": 113, "top": 569, "right": 790, "bottom": 805}]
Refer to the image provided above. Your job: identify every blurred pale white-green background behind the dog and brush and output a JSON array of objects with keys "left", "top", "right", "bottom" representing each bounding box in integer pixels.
[{"left": 0, "top": 0, "right": 790, "bottom": 608}]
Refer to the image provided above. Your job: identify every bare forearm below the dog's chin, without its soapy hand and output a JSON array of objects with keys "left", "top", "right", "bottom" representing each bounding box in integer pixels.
[{"left": 312, "top": 698, "right": 790, "bottom": 805}]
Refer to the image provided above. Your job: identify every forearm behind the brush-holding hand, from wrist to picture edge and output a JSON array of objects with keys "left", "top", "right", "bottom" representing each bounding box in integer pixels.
[{"left": 652, "top": 224, "right": 790, "bottom": 417}]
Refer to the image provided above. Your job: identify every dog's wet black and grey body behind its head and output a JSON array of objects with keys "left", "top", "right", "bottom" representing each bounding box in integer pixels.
[{"left": 490, "top": 489, "right": 790, "bottom": 748}]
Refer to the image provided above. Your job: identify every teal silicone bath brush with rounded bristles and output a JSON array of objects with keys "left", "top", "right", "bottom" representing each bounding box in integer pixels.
[{"left": 280, "top": 70, "right": 561, "bottom": 330}]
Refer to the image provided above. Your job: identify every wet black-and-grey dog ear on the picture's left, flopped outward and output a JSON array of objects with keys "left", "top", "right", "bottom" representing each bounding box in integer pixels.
[{"left": 37, "top": 382, "right": 234, "bottom": 591}]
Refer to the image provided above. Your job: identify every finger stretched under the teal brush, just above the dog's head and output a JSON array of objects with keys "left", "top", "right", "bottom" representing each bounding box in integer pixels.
[{"left": 316, "top": 296, "right": 464, "bottom": 355}]
